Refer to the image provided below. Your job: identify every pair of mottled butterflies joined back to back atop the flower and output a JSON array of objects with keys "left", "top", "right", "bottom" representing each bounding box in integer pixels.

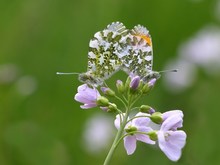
[{"left": 79, "top": 22, "right": 160, "bottom": 87}]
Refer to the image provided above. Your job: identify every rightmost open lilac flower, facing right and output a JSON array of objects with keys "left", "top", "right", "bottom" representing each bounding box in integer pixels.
[{"left": 157, "top": 110, "right": 186, "bottom": 161}]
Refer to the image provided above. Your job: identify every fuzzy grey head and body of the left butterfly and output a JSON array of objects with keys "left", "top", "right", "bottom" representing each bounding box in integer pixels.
[{"left": 79, "top": 72, "right": 103, "bottom": 87}]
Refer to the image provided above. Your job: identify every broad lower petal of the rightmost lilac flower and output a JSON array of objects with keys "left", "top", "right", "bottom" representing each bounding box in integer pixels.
[{"left": 158, "top": 131, "right": 186, "bottom": 161}]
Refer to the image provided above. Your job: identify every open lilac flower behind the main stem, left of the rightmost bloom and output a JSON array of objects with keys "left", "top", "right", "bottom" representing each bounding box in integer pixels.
[{"left": 115, "top": 112, "right": 155, "bottom": 155}]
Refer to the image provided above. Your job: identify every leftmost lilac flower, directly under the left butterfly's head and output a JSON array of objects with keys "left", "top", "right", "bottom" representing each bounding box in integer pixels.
[{"left": 74, "top": 84, "right": 100, "bottom": 109}]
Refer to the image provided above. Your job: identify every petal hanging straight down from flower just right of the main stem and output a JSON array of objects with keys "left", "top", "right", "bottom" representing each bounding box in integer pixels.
[{"left": 124, "top": 136, "right": 136, "bottom": 155}]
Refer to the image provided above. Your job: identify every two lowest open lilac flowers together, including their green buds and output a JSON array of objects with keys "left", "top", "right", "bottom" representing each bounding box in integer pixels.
[{"left": 115, "top": 110, "right": 186, "bottom": 161}]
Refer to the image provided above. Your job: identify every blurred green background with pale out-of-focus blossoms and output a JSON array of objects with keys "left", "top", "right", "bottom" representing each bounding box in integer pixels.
[{"left": 0, "top": 0, "right": 220, "bottom": 165}]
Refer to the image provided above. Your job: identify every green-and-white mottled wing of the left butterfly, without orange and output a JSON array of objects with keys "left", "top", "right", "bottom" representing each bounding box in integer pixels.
[{"left": 87, "top": 22, "right": 128, "bottom": 81}]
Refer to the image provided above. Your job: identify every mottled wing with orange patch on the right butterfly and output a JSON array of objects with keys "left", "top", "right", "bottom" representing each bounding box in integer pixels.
[{"left": 123, "top": 25, "right": 153, "bottom": 77}]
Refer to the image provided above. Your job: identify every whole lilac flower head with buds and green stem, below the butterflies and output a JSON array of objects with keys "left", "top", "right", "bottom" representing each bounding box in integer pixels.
[{"left": 75, "top": 76, "right": 186, "bottom": 164}]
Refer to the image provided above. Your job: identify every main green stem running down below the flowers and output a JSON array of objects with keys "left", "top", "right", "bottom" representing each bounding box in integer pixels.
[{"left": 103, "top": 108, "right": 129, "bottom": 165}]
